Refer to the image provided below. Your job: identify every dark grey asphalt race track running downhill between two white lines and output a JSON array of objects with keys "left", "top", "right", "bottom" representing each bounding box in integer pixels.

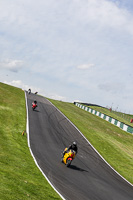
[{"left": 27, "top": 93, "right": 133, "bottom": 200}]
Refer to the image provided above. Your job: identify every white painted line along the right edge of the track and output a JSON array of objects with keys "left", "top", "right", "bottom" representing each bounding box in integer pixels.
[{"left": 47, "top": 99, "right": 133, "bottom": 186}]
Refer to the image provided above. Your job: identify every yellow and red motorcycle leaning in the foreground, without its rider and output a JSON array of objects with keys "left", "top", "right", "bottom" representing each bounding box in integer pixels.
[{"left": 61, "top": 148, "right": 76, "bottom": 167}]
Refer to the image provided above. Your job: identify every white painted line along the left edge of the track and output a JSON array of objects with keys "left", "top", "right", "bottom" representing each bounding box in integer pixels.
[{"left": 25, "top": 91, "right": 66, "bottom": 200}]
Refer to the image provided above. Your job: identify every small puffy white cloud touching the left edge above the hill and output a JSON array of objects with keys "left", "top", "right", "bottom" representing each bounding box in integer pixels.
[{"left": 0, "top": 59, "right": 23, "bottom": 72}]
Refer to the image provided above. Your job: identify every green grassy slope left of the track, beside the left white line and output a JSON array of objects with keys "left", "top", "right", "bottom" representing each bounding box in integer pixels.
[{"left": 0, "top": 83, "right": 61, "bottom": 200}]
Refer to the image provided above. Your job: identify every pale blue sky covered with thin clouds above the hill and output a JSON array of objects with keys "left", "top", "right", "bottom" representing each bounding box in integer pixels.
[{"left": 0, "top": 0, "right": 133, "bottom": 114}]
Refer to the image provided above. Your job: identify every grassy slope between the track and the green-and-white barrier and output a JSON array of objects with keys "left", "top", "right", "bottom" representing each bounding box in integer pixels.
[{"left": 50, "top": 99, "right": 133, "bottom": 184}]
